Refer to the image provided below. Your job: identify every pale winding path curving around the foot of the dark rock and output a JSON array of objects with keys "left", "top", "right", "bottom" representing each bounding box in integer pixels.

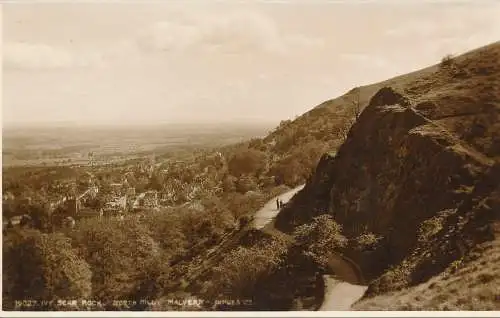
[{"left": 253, "top": 185, "right": 368, "bottom": 311}]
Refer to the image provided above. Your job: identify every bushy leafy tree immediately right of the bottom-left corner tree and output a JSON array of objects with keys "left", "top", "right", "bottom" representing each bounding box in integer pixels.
[{"left": 70, "top": 219, "right": 162, "bottom": 303}]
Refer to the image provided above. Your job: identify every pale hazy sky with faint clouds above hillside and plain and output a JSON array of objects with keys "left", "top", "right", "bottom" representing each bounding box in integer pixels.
[{"left": 2, "top": 0, "right": 500, "bottom": 124}]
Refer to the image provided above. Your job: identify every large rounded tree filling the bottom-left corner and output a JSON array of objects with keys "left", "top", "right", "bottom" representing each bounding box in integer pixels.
[{"left": 3, "top": 229, "right": 92, "bottom": 310}]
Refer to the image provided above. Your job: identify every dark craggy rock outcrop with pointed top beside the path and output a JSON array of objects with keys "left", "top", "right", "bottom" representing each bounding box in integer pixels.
[{"left": 276, "top": 87, "right": 493, "bottom": 281}]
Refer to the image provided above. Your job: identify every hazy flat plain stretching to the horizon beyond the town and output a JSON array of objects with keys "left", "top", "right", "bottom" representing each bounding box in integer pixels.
[{"left": 2, "top": 123, "right": 271, "bottom": 168}]
